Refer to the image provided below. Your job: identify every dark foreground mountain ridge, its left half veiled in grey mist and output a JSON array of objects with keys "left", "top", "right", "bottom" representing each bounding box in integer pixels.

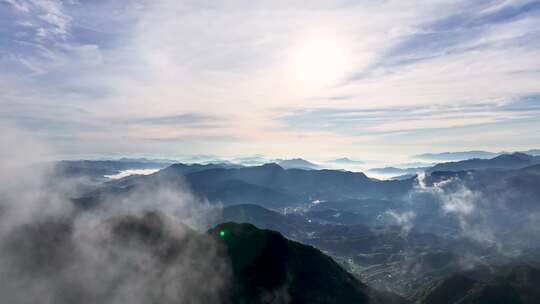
[{"left": 0, "top": 212, "right": 406, "bottom": 304}]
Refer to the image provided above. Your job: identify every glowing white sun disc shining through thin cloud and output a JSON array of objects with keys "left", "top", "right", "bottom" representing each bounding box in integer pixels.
[{"left": 290, "top": 36, "right": 349, "bottom": 88}]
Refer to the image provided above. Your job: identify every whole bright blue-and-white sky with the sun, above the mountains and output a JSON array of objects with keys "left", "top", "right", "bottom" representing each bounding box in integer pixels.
[{"left": 0, "top": 0, "right": 540, "bottom": 159}]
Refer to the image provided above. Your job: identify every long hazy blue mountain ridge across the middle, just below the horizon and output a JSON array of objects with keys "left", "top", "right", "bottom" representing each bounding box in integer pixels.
[{"left": 93, "top": 164, "right": 414, "bottom": 209}]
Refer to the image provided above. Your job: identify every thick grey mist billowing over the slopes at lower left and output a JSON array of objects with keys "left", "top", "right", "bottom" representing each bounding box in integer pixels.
[{"left": 0, "top": 126, "right": 231, "bottom": 304}]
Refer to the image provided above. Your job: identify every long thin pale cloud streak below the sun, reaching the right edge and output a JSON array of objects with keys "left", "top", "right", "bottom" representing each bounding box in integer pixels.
[{"left": 280, "top": 96, "right": 539, "bottom": 135}]
